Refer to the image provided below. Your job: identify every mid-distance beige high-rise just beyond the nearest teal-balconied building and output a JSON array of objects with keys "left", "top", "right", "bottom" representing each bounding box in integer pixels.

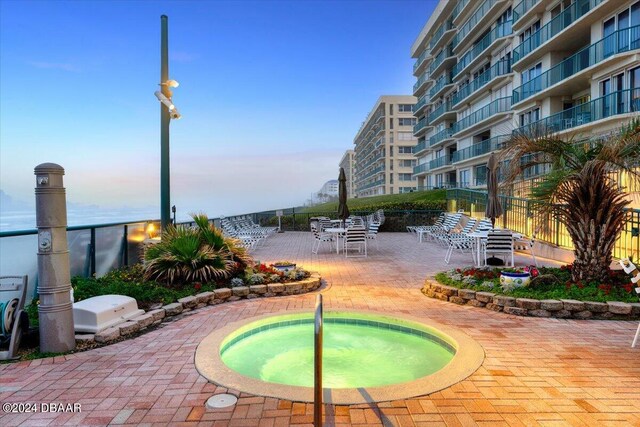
[{"left": 353, "top": 95, "right": 416, "bottom": 197}]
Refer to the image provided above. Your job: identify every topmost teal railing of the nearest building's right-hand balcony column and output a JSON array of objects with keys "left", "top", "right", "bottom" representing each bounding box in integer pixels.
[{"left": 513, "top": 0, "right": 603, "bottom": 63}]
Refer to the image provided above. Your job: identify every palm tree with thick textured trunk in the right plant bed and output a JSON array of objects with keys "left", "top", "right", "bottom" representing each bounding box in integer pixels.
[{"left": 502, "top": 119, "right": 640, "bottom": 282}]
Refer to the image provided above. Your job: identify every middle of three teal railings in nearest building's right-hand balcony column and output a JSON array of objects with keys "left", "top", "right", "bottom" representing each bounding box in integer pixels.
[{"left": 513, "top": 25, "right": 640, "bottom": 104}]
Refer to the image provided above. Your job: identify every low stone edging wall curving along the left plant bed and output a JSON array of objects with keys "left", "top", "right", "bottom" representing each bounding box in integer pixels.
[{"left": 76, "top": 273, "right": 321, "bottom": 345}]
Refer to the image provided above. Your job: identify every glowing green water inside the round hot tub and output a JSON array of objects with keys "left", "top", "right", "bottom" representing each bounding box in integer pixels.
[{"left": 220, "top": 313, "right": 455, "bottom": 388}]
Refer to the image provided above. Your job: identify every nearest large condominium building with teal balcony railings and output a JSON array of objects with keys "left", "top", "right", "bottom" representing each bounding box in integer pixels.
[{"left": 411, "top": 0, "right": 640, "bottom": 191}]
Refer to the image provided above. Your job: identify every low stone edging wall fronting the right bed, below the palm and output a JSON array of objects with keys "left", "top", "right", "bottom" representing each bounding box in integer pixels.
[{"left": 422, "top": 279, "right": 640, "bottom": 320}]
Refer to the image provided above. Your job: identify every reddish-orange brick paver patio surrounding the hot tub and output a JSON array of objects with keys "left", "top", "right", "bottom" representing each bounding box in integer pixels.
[{"left": 0, "top": 232, "right": 640, "bottom": 426}]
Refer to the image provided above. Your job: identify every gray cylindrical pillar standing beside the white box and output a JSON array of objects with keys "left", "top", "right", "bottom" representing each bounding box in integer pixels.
[{"left": 34, "top": 163, "right": 76, "bottom": 353}]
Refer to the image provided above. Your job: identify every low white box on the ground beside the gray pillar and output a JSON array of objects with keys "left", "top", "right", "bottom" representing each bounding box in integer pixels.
[{"left": 73, "top": 295, "right": 144, "bottom": 334}]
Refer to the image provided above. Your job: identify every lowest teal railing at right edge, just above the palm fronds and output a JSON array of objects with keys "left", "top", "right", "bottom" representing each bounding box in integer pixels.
[{"left": 513, "top": 87, "right": 640, "bottom": 136}]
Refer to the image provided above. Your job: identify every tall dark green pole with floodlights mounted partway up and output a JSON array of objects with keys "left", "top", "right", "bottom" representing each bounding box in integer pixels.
[{"left": 155, "top": 15, "right": 180, "bottom": 230}]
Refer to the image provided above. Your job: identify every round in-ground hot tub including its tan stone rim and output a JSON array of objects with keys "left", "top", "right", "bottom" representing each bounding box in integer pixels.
[{"left": 196, "top": 311, "right": 484, "bottom": 404}]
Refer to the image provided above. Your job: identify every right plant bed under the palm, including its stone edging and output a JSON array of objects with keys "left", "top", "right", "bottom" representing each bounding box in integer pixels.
[{"left": 422, "top": 265, "right": 640, "bottom": 320}]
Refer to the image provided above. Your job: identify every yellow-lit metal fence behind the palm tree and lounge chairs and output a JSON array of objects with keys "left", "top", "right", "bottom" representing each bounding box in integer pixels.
[{"left": 447, "top": 188, "right": 640, "bottom": 258}]
